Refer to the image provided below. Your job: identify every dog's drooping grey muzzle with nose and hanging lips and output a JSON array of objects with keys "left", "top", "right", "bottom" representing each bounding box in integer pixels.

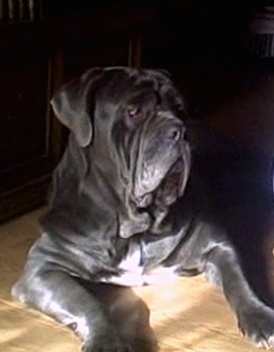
[{"left": 134, "top": 116, "right": 190, "bottom": 208}]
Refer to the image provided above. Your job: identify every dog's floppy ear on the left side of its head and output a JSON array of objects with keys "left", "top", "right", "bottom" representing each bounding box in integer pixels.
[{"left": 51, "top": 67, "right": 103, "bottom": 147}]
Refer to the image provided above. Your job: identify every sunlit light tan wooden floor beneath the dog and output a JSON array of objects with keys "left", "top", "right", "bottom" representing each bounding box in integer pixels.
[{"left": 0, "top": 209, "right": 272, "bottom": 352}]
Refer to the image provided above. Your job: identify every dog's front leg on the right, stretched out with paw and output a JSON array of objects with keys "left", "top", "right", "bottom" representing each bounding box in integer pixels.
[{"left": 205, "top": 242, "right": 274, "bottom": 349}]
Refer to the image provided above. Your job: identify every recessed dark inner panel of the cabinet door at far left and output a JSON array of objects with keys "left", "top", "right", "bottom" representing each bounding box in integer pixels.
[{"left": 0, "top": 47, "right": 48, "bottom": 173}]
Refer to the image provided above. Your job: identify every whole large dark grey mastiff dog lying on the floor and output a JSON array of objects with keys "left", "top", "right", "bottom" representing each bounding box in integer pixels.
[{"left": 13, "top": 68, "right": 274, "bottom": 352}]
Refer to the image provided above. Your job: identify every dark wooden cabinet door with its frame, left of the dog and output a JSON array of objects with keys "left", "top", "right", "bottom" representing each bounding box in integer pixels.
[{"left": 0, "top": 48, "right": 59, "bottom": 221}]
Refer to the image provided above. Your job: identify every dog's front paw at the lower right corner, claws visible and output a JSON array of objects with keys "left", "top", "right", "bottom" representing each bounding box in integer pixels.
[{"left": 238, "top": 305, "right": 274, "bottom": 349}]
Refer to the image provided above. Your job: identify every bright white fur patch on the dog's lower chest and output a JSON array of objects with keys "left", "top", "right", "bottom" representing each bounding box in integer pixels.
[{"left": 101, "top": 243, "right": 178, "bottom": 286}]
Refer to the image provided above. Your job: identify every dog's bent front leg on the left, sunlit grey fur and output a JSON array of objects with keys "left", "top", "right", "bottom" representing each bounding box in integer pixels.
[{"left": 12, "top": 270, "right": 132, "bottom": 352}]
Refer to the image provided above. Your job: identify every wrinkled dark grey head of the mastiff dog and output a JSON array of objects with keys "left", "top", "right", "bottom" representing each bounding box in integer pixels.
[{"left": 52, "top": 67, "right": 190, "bottom": 236}]
